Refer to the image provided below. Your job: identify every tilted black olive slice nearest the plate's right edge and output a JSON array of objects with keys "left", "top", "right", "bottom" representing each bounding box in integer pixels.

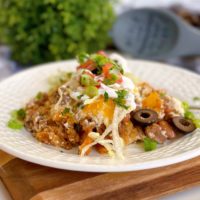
[{"left": 172, "top": 117, "right": 196, "bottom": 133}]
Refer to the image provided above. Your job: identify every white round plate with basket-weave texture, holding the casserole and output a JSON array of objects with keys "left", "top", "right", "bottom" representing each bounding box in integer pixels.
[{"left": 0, "top": 60, "right": 200, "bottom": 172}]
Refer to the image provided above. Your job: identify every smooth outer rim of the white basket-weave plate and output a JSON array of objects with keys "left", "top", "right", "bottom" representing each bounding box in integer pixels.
[{"left": 0, "top": 59, "right": 200, "bottom": 172}]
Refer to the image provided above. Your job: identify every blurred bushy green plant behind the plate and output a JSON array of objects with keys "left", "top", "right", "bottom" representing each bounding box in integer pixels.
[{"left": 0, "top": 0, "right": 115, "bottom": 65}]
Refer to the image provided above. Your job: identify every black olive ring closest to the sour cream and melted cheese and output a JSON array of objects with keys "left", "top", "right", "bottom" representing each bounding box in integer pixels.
[{"left": 133, "top": 109, "right": 158, "bottom": 124}]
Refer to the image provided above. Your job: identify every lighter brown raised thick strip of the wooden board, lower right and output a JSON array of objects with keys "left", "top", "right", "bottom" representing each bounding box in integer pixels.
[{"left": 31, "top": 158, "right": 200, "bottom": 200}]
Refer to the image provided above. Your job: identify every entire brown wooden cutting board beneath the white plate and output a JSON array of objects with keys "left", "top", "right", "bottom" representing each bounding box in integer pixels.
[{"left": 0, "top": 151, "right": 200, "bottom": 200}]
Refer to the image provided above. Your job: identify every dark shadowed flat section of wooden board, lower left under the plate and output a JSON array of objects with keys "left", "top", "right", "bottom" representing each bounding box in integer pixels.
[{"left": 0, "top": 158, "right": 98, "bottom": 200}]
